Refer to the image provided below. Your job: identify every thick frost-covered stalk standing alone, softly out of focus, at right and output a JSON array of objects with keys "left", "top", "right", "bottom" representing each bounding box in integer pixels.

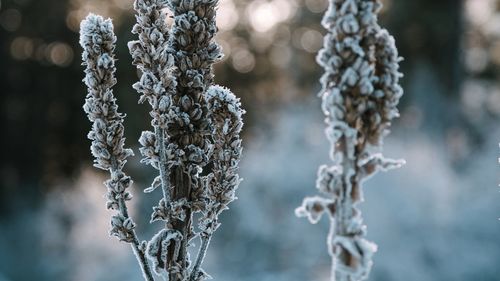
[{"left": 296, "top": 0, "right": 404, "bottom": 281}]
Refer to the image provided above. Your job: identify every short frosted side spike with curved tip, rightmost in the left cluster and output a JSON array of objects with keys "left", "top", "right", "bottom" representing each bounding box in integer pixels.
[{"left": 191, "top": 86, "right": 245, "bottom": 280}]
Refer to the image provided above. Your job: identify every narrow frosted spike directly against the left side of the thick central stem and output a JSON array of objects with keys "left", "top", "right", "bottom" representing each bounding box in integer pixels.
[{"left": 129, "top": 1, "right": 175, "bottom": 208}]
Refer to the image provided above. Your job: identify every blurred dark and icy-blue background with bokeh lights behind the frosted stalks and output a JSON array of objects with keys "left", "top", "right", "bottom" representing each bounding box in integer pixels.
[{"left": 0, "top": 0, "right": 500, "bottom": 281}]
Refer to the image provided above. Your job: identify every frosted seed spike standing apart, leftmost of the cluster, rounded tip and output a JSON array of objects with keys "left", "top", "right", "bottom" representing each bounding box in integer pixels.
[{"left": 80, "top": 14, "right": 154, "bottom": 281}]
